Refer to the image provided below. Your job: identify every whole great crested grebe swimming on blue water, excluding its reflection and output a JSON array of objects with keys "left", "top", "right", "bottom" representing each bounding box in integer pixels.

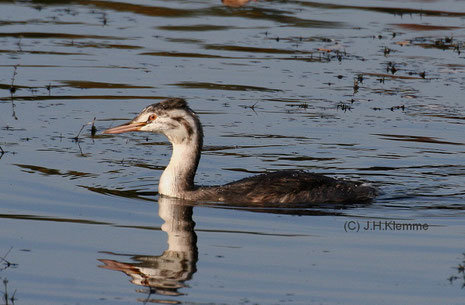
[{"left": 103, "top": 98, "right": 377, "bottom": 206}]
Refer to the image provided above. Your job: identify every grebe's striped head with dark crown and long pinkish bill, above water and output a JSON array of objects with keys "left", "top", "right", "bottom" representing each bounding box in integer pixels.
[{"left": 103, "top": 98, "right": 203, "bottom": 144}]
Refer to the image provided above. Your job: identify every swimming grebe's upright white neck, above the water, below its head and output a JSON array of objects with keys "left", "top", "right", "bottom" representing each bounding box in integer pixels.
[{"left": 158, "top": 134, "right": 202, "bottom": 198}]
